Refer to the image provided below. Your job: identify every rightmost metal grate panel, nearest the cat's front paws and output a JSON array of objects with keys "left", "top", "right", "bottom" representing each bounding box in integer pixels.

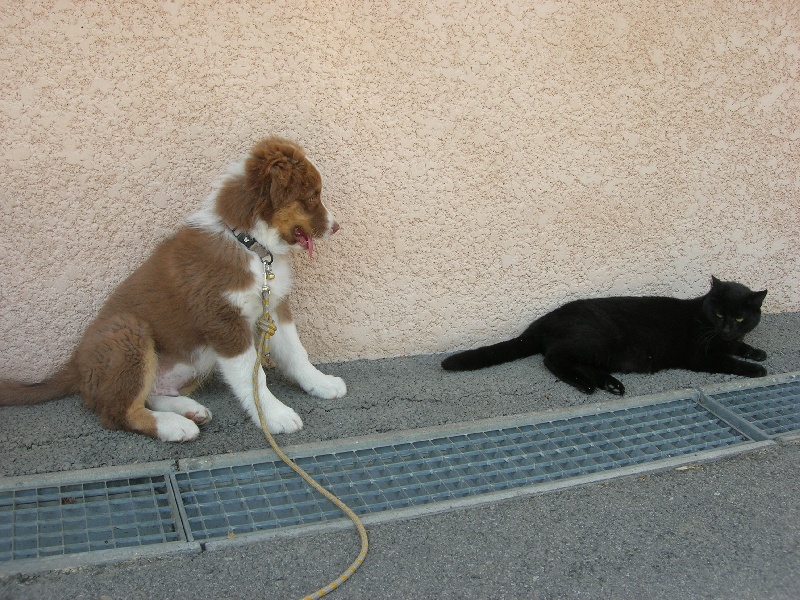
[{"left": 707, "top": 379, "right": 800, "bottom": 436}]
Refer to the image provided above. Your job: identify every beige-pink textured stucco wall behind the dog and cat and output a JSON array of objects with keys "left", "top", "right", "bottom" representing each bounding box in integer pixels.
[{"left": 0, "top": 0, "right": 800, "bottom": 377}]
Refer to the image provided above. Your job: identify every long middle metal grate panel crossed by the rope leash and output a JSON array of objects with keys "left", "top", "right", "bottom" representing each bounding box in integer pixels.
[{"left": 175, "top": 396, "right": 747, "bottom": 540}]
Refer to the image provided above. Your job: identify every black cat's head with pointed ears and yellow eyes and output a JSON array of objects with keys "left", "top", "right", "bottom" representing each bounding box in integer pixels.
[{"left": 703, "top": 276, "right": 767, "bottom": 342}]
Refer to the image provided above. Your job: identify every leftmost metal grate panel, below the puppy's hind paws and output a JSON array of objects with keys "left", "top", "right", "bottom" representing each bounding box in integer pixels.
[{"left": 0, "top": 475, "right": 183, "bottom": 562}]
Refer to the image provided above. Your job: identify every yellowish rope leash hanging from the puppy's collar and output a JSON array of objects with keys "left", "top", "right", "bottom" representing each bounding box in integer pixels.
[{"left": 253, "top": 274, "right": 369, "bottom": 600}]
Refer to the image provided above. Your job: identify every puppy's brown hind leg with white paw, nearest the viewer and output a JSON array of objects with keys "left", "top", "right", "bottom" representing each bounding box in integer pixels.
[{"left": 76, "top": 315, "right": 200, "bottom": 442}]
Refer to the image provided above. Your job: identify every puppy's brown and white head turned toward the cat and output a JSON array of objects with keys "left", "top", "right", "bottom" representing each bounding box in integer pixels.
[{"left": 217, "top": 137, "right": 339, "bottom": 256}]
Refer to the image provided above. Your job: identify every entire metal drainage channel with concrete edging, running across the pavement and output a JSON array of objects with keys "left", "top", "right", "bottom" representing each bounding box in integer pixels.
[{"left": 7, "top": 372, "right": 800, "bottom": 575}]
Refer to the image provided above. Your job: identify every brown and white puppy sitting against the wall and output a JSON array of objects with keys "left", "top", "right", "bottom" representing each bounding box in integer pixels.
[{"left": 0, "top": 137, "right": 347, "bottom": 442}]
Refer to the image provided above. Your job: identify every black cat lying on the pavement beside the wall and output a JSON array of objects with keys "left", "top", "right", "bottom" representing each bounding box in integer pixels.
[{"left": 442, "top": 277, "right": 767, "bottom": 395}]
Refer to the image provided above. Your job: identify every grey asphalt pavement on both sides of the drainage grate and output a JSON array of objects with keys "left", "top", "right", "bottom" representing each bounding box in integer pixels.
[{"left": 0, "top": 313, "right": 800, "bottom": 599}]
